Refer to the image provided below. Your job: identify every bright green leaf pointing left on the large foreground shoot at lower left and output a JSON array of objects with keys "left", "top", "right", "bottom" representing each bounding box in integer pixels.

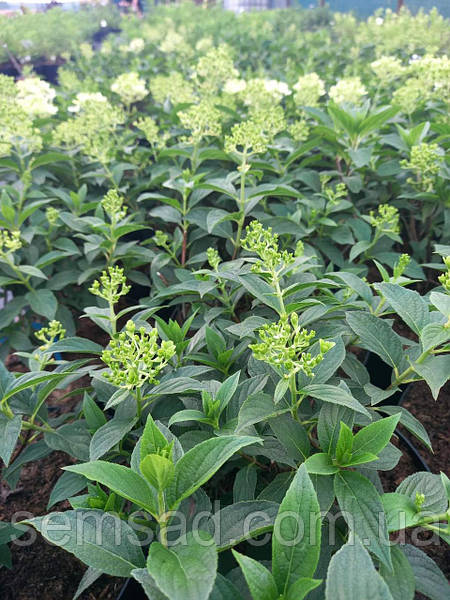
[{"left": 64, "top": 460, "right": 158, "bottom": 515}]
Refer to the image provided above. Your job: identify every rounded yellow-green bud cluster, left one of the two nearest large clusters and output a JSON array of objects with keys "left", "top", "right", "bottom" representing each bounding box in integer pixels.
[{"left": 102, "top": 321, "right": 176, "bottom": 389}]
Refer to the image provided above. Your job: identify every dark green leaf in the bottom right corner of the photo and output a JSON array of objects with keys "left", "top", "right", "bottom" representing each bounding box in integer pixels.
[{"left": 401, "top": 544, "right": 450, "bottom": 600}]
